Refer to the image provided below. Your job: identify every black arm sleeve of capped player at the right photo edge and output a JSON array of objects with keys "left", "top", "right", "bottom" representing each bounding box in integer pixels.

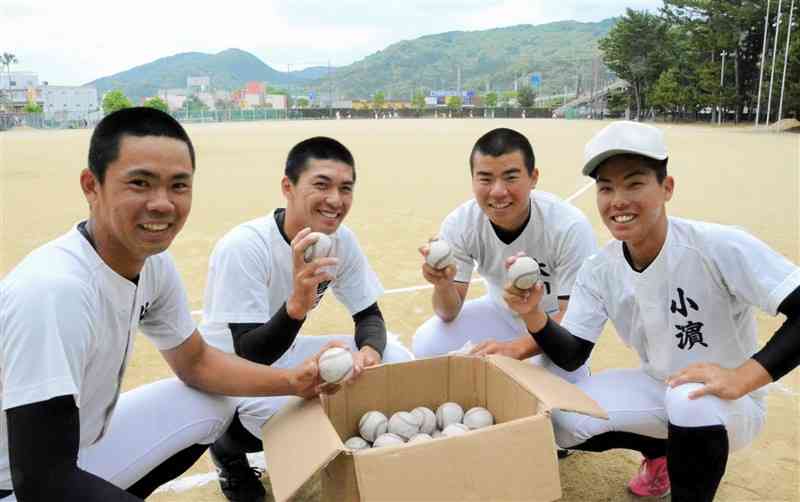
[{"left": 753, "top": 288, "right": 800, "bottom": 381}]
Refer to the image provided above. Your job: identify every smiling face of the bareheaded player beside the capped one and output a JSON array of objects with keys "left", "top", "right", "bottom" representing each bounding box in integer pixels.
[{"left": 472, "top": 150, "right": 539, "bottom": 230}]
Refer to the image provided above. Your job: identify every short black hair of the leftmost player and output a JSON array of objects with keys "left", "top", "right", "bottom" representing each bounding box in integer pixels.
[{"left": 89, "top": 106, "right": 194, "bottom": 184}]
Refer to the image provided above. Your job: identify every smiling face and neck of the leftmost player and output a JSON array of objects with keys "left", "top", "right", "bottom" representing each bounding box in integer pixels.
[{"left": 81, "top": 135, "right": 194, "bottom": 278}]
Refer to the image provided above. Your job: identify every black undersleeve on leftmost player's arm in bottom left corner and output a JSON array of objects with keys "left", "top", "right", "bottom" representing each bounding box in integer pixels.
[{"left": 6, "top": 396, "right": 142, "bottom": 502}]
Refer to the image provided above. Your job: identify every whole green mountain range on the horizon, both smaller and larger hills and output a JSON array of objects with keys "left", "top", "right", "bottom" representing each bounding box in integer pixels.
[{"left": 87, "top": 18, "right": 616, "bottom": 99}]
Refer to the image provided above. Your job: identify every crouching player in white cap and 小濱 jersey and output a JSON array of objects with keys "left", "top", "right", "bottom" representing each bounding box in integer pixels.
[{"left": 478, "top": 122, "right": 800, "bottom": 502}]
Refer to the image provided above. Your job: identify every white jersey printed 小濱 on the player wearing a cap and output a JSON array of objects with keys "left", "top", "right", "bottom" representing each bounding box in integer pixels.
[{"left": 563, "top": 218, "right": 800, "bottom": 394}]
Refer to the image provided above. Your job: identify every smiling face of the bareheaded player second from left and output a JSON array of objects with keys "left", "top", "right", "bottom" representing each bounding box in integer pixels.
[{"left": 281, "top": 158, "right": 355, "bottom": 239}]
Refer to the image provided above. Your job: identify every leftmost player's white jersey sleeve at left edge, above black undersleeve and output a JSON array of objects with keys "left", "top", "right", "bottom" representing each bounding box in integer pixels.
[{"left": 0, "top": 274, "right": 91, "bottom": 410}]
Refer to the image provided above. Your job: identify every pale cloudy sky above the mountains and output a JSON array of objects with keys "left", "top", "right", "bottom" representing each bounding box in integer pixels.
[{"left": 0, "top": 0, "right": 662, "bottom": 85}]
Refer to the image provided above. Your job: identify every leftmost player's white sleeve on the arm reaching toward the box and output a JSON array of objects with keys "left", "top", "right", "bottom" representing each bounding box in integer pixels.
[{"left": 139, "top": 253, "right": 195, "bottom": 350}]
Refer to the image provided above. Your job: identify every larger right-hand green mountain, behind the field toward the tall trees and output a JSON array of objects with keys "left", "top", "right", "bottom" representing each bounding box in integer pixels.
[{"left": 310, "top": 18, "right": 616, "bottom": 99}]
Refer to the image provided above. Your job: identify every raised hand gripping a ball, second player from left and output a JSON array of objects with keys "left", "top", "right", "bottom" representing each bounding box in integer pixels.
[{"left": 286, "top": 227, "right": 339, "bottom": 321}]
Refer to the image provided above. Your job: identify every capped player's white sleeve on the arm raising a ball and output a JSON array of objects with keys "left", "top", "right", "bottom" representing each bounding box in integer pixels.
[{"left": 561, "top": 255, "right": 608, "bottom": 343}]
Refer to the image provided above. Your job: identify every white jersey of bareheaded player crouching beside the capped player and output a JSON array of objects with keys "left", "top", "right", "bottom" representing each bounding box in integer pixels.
[{"left": 439, "top": 190, "right": 597, "bottom": 313}]
